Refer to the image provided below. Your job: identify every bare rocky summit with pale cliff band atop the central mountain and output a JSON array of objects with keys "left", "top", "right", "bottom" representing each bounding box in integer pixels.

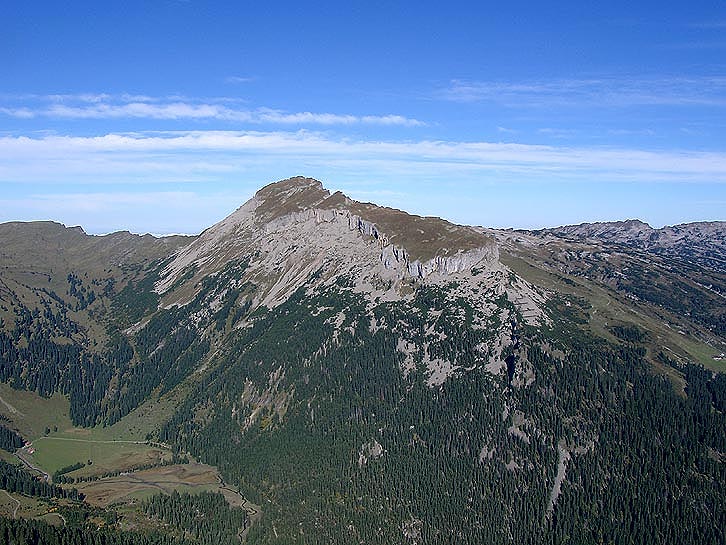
[{"left": 157, "top": 176, "right": 498, "bottom": 302}]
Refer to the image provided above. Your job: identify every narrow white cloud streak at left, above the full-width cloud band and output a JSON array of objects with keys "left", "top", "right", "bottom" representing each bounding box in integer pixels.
[{"left": 0, "top": 94, "right": 424, "bottom": 127}]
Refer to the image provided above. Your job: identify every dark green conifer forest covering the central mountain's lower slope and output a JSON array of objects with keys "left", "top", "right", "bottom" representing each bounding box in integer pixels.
[{"left": 162, "top": 278, "right": 726, "bottom": 544}]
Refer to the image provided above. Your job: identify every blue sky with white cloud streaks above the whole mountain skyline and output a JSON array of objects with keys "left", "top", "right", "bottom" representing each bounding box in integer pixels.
[{"left": 0, "top": 0, "right": 726, "bottom": 233}]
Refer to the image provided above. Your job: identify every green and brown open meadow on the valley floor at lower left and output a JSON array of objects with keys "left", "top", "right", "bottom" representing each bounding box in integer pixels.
[{"left": 0, "top": 383, "right": 256, "bottom": 506}]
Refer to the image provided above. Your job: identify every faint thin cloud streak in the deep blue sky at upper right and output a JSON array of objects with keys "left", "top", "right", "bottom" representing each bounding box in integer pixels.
[{"left": 435, "top": 76, "right": 726, "bottom": 108}]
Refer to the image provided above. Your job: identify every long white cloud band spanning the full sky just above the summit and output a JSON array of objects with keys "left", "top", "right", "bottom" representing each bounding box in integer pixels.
[{"left": 0, "top": 131, "right": 726, "bottom": 184}]
